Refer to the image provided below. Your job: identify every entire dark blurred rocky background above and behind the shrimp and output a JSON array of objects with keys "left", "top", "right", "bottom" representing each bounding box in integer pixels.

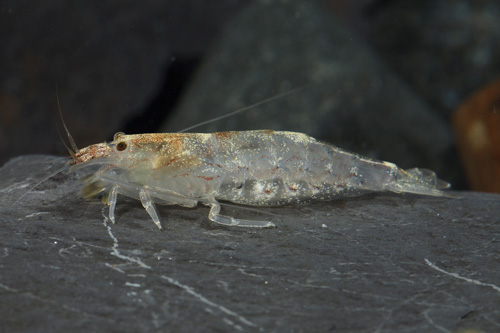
[{"left": 0, "top": 0, "right": 500, "bottom": 191}]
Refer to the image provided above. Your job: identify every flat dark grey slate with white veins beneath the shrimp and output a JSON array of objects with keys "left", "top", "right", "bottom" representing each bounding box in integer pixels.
[{"left": 0, "top": 155, "right": 500, "bottom": 332}]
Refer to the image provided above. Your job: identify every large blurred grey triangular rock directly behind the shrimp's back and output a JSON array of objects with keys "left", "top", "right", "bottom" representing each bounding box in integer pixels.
[{"left": 163, "top": 0, "right": 459, "bottom": 183}]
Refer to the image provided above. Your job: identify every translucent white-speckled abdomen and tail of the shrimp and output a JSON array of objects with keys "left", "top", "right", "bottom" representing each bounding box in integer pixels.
[{"left": 209, "top": 131, "right": 450, "bottom": 206}]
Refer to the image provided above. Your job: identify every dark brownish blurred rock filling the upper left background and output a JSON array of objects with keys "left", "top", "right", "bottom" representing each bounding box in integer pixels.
[{"left": 0, "top": 0, "right": 250, "bottom": 163}]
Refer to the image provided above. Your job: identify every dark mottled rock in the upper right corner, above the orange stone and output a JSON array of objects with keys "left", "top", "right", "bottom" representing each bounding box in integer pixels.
[{"left": 370, "top": 0, "right": 500, "bottom": 113}]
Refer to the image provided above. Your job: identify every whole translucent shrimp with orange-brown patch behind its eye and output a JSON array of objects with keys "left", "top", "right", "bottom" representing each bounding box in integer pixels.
[{"left": 71, "top": 130, "right": 450, "bottom": 230}]
